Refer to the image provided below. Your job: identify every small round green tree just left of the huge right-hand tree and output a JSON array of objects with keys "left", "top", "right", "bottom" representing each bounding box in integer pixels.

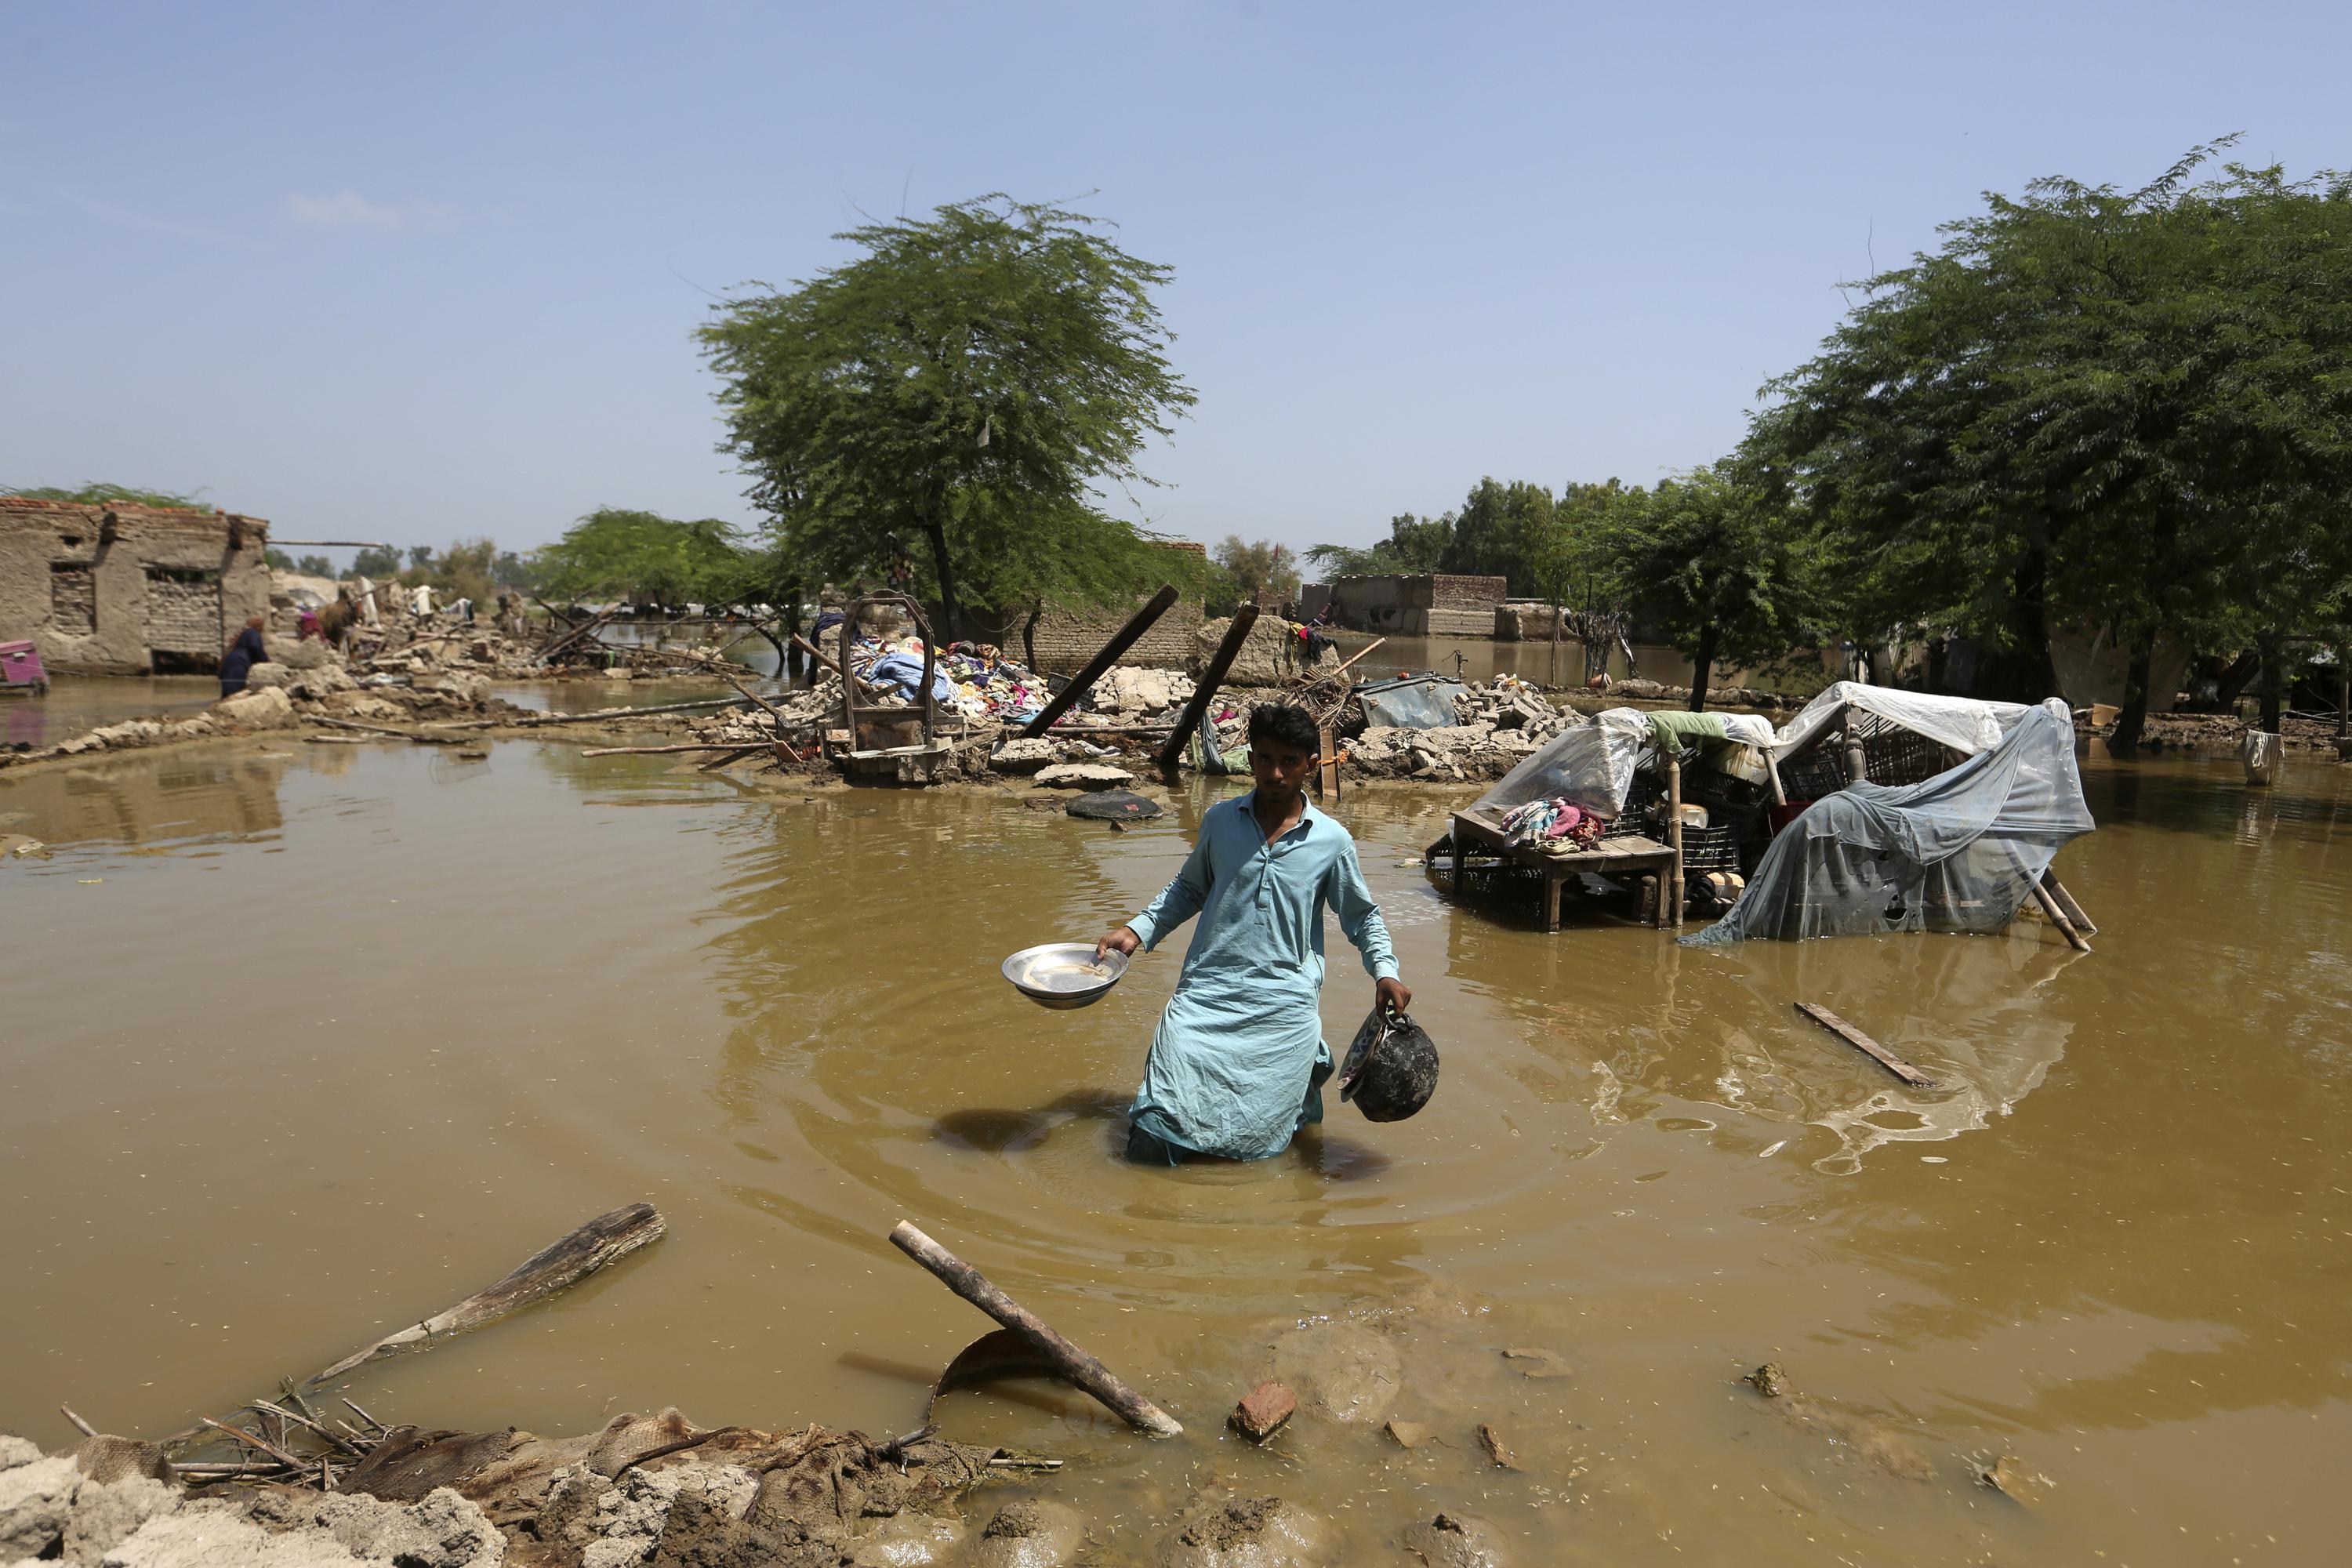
[{"left": 1604, "top": 463, "right": 1820, "bottom": 713}]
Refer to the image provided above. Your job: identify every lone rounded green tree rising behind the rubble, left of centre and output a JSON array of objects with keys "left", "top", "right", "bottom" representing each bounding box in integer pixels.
[{"left": 699, "top": 195, "right": 1192, "bottom": 635}]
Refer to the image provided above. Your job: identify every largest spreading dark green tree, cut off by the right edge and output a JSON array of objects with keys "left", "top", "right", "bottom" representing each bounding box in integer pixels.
[{"left": 1745, "top": 148, "right": 2352, "bottom": 719}]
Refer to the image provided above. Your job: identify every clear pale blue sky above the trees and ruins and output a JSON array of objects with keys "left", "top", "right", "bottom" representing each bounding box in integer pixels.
[{"left": 0, "top": 0, "right": 2352, "bottom": 571}]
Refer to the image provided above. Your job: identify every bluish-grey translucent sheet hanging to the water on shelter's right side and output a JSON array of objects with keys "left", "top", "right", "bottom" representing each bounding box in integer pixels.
[{"left": 1682, "top": 699, "right": 2096, "bottom": 947}]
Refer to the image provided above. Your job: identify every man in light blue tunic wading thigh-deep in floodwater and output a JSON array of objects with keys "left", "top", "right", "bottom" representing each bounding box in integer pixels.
[{"left": 1094, "top": 708, "right": 1414, "bottom": 1166}]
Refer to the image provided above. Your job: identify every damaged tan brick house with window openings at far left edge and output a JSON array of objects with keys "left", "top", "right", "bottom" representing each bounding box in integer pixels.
[{"left": 0, "top": 496, "right": 270, "bottom": 675}]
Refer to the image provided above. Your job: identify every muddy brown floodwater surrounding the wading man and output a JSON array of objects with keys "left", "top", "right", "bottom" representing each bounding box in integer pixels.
[{"left": 0, "top": 743, "right": 2352, "bottom": 1568}]
